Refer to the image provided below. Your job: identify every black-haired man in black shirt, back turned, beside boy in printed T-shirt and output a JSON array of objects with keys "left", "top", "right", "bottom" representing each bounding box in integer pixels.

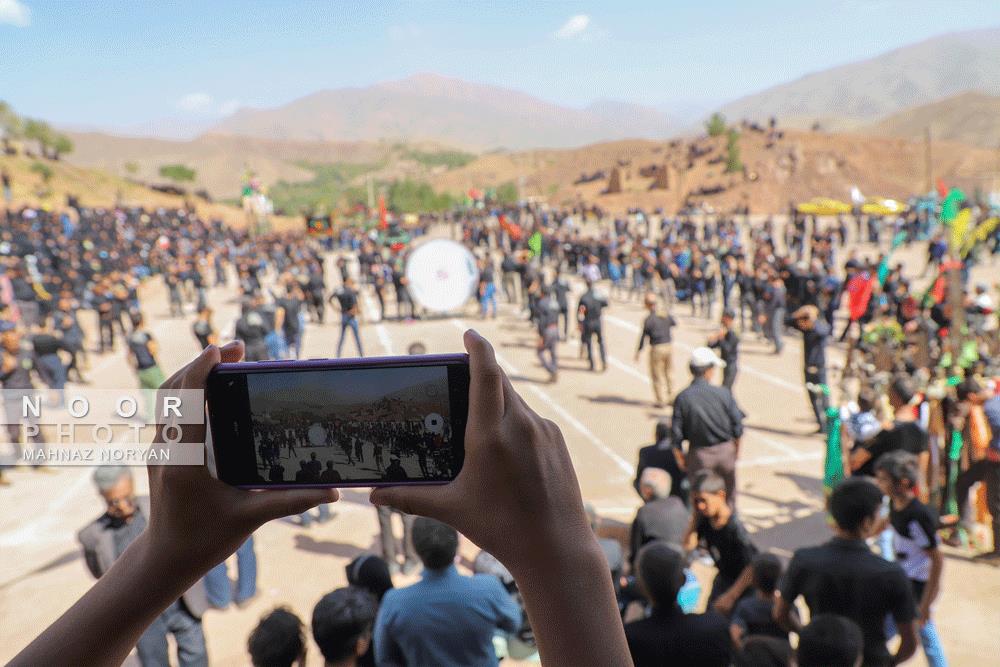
[{"left": 774, "top": 477, "right": 917, "bottom": 667}]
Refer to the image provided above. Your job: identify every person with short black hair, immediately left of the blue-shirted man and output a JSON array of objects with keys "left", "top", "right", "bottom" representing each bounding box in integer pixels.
[{"left": 312, "top": 586, "right": 376, "bottom": 667}]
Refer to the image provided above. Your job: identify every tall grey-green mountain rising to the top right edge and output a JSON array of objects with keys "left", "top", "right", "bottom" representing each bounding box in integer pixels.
[{"left": 721, "top": 28, "right": 1000, "bottom": 130}]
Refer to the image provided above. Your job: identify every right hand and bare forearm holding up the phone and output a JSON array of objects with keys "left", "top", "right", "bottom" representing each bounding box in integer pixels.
[{"left": 371, "top": 331, "right": 632, "bottom": 667}]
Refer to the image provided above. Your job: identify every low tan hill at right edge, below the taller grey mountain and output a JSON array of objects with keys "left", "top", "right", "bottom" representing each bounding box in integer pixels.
[{"left": 864, "top": 92, "right": 1000, "bottom": 148}]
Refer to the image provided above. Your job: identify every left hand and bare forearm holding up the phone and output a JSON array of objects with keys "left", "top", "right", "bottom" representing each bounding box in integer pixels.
[{"left": 10, "top": 343, "right": 338, "bottom": 667}]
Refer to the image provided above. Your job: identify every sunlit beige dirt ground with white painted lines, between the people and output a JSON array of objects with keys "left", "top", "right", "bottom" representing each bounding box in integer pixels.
[{"left": 0, "top": 228, "right": 1000, "bottom": 666}]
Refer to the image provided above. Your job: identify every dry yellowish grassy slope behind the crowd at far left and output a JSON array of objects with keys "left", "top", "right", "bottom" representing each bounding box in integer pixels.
[{"left": 0, "top": 154, "right": 302, "bottom": 229}]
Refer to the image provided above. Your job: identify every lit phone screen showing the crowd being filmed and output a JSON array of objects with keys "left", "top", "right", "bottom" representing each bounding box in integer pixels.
[{"left": 247, "top": 366, "right": 457, "bottom": 484}]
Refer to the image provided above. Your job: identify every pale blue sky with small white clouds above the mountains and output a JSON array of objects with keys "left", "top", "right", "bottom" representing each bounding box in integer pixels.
[{"left": 0, "top": 0, "right": 1000, "bottom": 132}]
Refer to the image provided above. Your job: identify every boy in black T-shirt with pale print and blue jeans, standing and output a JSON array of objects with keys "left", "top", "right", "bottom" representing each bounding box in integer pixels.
[{"left": 875, "top": 450, "right": 947, "bottom": 667}]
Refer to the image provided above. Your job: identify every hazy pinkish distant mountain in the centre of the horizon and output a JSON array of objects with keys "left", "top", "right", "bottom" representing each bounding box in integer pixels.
[{"left": 210, "top": 74, "right": 669, "bottom": 150}]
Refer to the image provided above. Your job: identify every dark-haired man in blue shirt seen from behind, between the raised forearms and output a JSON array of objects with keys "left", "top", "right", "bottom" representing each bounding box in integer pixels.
[{"left": 375, "top": 517, "right": 521, "bottom": 665}]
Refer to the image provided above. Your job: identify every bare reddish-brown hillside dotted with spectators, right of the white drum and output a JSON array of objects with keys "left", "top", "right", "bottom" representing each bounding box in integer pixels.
[{"left": 431, "top": 129, "right": 996, "bottom": 213}]
